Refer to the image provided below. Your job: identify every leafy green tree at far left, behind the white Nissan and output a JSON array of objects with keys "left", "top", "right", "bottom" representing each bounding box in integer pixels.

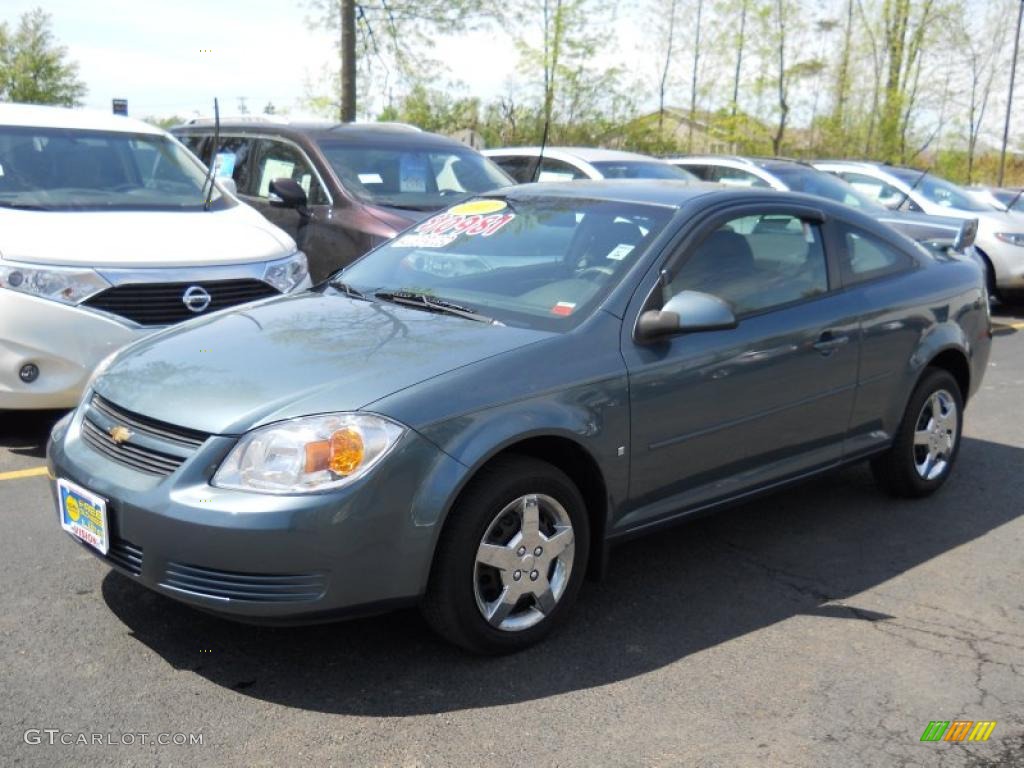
[{"left": 0, "top": 8, "right": 86, "bottom": 106}]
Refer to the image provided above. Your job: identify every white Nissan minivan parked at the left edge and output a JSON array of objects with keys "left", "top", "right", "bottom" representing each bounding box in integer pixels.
[{"left": 0, "top": 104, "right": 309, "bottom": 411}]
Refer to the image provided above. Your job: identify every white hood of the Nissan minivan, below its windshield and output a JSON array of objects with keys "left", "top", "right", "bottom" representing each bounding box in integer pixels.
[{"left": 0, "top": 204, "right": 295, "bottom": 268}]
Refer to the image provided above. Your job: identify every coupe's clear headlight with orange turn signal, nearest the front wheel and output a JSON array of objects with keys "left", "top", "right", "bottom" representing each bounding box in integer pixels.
[{"left": 211, "top": 414, "right": 406, "bottom": 494}]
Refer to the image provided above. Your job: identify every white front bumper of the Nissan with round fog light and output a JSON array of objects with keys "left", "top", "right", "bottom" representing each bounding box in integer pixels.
[{"left": 0, "top": 290, "right": 149, "bottom": 411}]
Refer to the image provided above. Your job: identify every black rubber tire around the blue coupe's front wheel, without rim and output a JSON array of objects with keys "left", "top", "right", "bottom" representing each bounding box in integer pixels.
[{"left": 421, "top": 456, "right": 590, "bottom": 654}]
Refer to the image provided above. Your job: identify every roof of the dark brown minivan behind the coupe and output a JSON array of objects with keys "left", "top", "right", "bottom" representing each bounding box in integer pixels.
[{"left": 171, "top": 116, "right": 469, "bottom": 150}]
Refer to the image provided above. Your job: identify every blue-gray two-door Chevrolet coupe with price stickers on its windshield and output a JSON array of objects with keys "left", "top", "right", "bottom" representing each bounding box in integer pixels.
[{"left": 48, "top": 181, "right": 991, "bottom": 653}]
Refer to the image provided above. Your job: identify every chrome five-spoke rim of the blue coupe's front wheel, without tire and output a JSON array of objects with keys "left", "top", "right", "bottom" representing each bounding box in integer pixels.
[{"left": 473, "top": 494, "right": 575, "bottom": 632}]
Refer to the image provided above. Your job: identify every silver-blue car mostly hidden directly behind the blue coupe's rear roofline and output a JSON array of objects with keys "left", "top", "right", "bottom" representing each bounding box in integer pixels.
[{"left": 668, "top": 155, "right": 984, "bottom": 259}]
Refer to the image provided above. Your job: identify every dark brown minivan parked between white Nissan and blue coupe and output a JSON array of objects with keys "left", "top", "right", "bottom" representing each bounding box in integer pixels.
[{"left": 172, "top": 116, "right": 513, "bottom": 282}]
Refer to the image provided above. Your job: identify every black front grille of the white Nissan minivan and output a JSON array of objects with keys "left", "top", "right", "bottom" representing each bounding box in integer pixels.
[{"left": 85, "top": 278, "right": 279, "bottom": 326}]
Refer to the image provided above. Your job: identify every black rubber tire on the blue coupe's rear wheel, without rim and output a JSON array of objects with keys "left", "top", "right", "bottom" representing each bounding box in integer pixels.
[{"left": 871, "top": 368, "right": 964, "bottom": 499}]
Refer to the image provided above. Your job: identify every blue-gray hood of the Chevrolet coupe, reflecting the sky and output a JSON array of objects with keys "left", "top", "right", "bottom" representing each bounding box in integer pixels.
[{"left": 94, "top": 292, "right": 550, "bottom": 434}]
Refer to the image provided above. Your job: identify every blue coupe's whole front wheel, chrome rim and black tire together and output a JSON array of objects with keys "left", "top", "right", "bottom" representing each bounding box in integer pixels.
[{"left": 423, "top": 457, "right": 590, "bottom": 653}]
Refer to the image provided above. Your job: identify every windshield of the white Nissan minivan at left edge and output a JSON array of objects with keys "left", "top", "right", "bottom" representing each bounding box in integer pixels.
[{"left": 0, "top": 126, "right": 228, "bottom": 211}]
